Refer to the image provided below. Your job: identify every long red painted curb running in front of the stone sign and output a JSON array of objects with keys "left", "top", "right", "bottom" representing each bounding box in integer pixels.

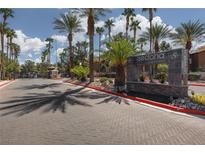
[{"left": 64, "top": 81, "right": 205, "bottom": 116}]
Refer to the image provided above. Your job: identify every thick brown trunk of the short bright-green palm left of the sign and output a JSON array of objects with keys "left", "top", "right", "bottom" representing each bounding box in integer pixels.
[{"left": 115, "top": 64, "right": 125, "bottom": 91}]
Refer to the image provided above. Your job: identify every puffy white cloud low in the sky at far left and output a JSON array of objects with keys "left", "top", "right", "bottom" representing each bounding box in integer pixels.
[{"left": 14, "top": 30, "right": 46, "bottom": 52}]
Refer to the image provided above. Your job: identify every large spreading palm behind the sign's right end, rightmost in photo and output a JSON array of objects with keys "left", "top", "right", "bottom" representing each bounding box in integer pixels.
[{"left": 172, "top": 20, "right": 205, "bottom": 70}]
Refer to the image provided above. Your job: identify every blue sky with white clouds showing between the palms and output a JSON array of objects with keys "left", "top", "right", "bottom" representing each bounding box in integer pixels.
[{"left": 1, "top": 8, "right": 205, "bottom": 64}]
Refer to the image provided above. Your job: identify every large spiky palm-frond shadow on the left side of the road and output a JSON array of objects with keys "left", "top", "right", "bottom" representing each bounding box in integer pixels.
[{"left": 0, "top": 87, "right": 92, "bottom": 116}]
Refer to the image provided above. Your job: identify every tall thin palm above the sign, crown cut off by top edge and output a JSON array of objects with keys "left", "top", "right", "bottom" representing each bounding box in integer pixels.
[{"left": 142, "top": 8, "right": 157, "bottom": 52}]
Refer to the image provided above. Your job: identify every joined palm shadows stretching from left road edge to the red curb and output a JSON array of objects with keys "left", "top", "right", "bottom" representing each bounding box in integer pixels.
[{"left": 0, "top": 84, "right": 129, "bottom": 116}]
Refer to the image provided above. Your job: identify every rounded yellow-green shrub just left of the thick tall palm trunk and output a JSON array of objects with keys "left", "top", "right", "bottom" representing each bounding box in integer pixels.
[{"left": 71, "top": 66, "right": 89, "bottom": 81}]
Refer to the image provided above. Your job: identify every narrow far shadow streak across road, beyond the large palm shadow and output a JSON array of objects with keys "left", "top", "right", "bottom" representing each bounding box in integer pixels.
[{"left": 16, "top": 83, "right": 62, "bottom": 90}]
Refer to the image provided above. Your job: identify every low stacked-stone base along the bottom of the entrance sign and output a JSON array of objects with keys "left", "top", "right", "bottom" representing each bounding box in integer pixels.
[{"left": 127, "top": 81, "right": 188, "bottom": 97}]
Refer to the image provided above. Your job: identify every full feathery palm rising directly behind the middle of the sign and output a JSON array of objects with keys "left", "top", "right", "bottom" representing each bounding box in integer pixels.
[{"left": 141, "top": 24, "right": 171, "bottom": 53}]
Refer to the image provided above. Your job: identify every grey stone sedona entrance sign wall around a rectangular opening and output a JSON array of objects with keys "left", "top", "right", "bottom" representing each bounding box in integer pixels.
[{"left": 127, "top": 49, "right": 188, "bottom": 97}]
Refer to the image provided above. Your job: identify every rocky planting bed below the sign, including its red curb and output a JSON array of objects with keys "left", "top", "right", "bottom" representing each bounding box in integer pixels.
[{"left": 65, "top": 78, "right": 205, "bottom": 115}]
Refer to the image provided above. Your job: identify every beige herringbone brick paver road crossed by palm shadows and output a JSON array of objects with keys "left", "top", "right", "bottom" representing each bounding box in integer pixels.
[{"left": 0, "top": 79, "right": 205, "bottom": 144}]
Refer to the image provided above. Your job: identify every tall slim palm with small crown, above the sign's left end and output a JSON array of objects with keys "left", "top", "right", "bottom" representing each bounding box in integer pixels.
[{"left": 122, "top": 8, "right": 135, "bottom": 38}]
